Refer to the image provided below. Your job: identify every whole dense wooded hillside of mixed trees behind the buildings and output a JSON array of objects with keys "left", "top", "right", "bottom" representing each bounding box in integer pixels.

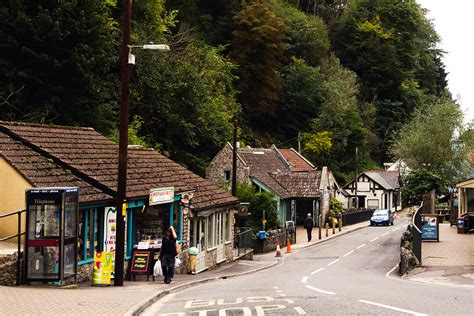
[{"left": 0, "top": 0, "right": 473, "bottom": 182}]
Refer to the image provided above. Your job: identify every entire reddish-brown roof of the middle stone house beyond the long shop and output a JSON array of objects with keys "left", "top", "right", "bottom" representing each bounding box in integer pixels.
[{"left": 237, "top": 147, "right": 321, "bottom": 199}]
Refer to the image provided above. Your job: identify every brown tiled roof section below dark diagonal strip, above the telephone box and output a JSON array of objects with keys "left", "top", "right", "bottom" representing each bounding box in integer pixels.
[{"left": 0, "top": 132, "right": 112, "bottom": 203}]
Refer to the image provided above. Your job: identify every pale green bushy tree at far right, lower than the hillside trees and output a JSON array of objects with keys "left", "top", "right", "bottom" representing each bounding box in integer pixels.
[{"left": 391, "top": 97, "right": 469, "bottom": 183}]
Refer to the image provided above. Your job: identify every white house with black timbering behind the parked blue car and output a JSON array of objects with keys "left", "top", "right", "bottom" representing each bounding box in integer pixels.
[{"left": 336, "top": 170, "right": 401, "bottom": 211}]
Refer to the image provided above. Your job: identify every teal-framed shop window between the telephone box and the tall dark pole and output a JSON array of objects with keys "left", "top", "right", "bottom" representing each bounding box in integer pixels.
[{"left": 77, "top": 208, "right": 102, "bottom": 264}]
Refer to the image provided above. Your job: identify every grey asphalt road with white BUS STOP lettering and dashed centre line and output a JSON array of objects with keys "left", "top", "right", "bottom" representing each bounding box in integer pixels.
[{"left": 143, "top": 218, "right": 474, "bottom": 316}]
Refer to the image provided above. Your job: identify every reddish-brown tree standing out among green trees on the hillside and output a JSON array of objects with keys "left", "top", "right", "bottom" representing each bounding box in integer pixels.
[{"left": 230, "top": 1, "right": 284, "bottom": 131}]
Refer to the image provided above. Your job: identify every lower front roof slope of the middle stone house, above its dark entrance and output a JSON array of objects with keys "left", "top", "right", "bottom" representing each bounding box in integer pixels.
[{"left": 271, "top": 170, "right": 321, "bottom": 198}]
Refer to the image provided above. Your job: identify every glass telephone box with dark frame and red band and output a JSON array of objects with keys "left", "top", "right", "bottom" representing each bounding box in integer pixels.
[{"left": 25, "top": 188, "right": 79, "bottom": 285}]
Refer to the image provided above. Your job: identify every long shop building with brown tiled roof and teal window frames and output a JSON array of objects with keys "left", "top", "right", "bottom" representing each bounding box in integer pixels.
[{"left": 0, "top": 122, "right": 238, "bottom": 282}]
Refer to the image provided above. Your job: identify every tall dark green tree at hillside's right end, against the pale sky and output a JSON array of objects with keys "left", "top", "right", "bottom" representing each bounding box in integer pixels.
[{"left": 330, "top": 0, "right": 446, "bottom": 162}]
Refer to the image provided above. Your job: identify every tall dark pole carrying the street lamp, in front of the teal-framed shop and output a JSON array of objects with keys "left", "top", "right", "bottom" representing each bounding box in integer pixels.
[{"left": 114, "top": 0, "right": 132, "bottom": 286}]
